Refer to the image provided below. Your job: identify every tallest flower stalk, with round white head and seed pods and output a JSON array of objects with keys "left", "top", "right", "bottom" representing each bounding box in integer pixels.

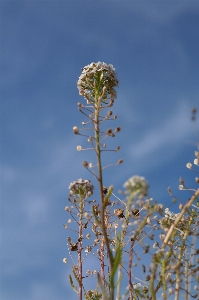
[{"left": 77, "top": 62, "right": 122, "bottom": 300}]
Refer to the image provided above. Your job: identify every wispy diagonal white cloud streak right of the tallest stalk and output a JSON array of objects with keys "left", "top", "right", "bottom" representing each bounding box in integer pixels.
[{"left": 127, "top": 101, "right": 193, "bottom": 166}]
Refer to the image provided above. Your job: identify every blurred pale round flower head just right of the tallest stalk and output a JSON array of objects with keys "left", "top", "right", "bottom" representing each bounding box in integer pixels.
[{"left": 123, "top": 175, "right": 149, "bottom": 196}]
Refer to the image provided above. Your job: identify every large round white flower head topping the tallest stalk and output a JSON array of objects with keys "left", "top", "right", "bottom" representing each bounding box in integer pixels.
[{"left": 77, "top": 62, "right": 118, "bottom": 102}]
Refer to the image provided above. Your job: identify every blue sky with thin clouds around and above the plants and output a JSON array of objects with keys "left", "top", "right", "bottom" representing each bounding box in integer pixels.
[{"left": 0, "top": 0, "right": 199, "bottom": 300}]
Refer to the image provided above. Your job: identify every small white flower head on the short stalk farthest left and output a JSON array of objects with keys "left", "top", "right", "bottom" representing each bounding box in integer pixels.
[{"left": 68, "top": 178, "right": 94, "bottom": 197}]
